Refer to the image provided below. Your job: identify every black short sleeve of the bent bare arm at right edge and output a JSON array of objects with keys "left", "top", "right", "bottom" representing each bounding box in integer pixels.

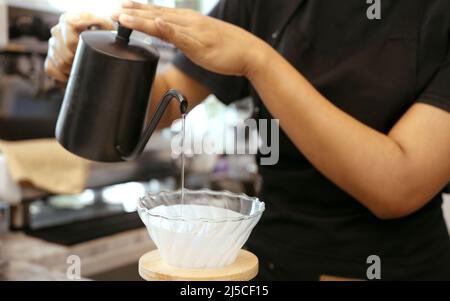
[{"left": 418, "top": 41, "right": 450, "bottom": 112}]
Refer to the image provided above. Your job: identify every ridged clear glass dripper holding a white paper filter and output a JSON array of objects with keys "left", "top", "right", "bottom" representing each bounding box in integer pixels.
[{"left": 138, "top": 189, "right": 265, "bottom": 268}]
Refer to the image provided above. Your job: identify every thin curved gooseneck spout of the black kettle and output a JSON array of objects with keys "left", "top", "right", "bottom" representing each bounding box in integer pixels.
[{"left": 116, "top": 89, "right": 188, "bottom": 161}]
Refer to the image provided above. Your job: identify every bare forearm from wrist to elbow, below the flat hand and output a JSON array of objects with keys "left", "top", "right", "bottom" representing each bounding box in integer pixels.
[{"left": 249, "top": 45, "right": 424, "bottom": 215}]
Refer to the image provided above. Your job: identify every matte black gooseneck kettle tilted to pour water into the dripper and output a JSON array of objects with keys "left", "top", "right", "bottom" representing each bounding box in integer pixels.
[{"left": 56, "top": 25, "right": 187, "bottom": 162}]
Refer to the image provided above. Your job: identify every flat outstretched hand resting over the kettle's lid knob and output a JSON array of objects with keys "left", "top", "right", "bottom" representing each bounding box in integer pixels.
[{"left": 112, "top": 1, "right": 269, "bottom": 76}]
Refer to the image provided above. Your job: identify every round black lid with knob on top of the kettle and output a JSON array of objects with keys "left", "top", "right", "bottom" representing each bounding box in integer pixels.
[{"left": 80, "top": 26, "right": 159, "bottom": 62}]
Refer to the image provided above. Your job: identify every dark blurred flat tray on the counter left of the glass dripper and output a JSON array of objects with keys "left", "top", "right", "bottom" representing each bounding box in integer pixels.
[{"left": 25, "top": 212, "right": 144, "bottom": 246}]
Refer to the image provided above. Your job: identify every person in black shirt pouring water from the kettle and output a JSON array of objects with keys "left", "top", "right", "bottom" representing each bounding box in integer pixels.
[{"left": 47, "top": 0, "right": 450, "bottom": 280}]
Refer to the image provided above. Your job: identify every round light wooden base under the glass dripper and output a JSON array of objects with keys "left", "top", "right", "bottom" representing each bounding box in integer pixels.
[{"left": 139, "top": 250, "right": 258, "bottom": 281}]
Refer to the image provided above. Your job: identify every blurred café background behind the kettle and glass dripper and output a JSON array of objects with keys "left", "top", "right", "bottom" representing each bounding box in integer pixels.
[{"left": 0, "top": 0, "right": 260, "bottom": 280}]
